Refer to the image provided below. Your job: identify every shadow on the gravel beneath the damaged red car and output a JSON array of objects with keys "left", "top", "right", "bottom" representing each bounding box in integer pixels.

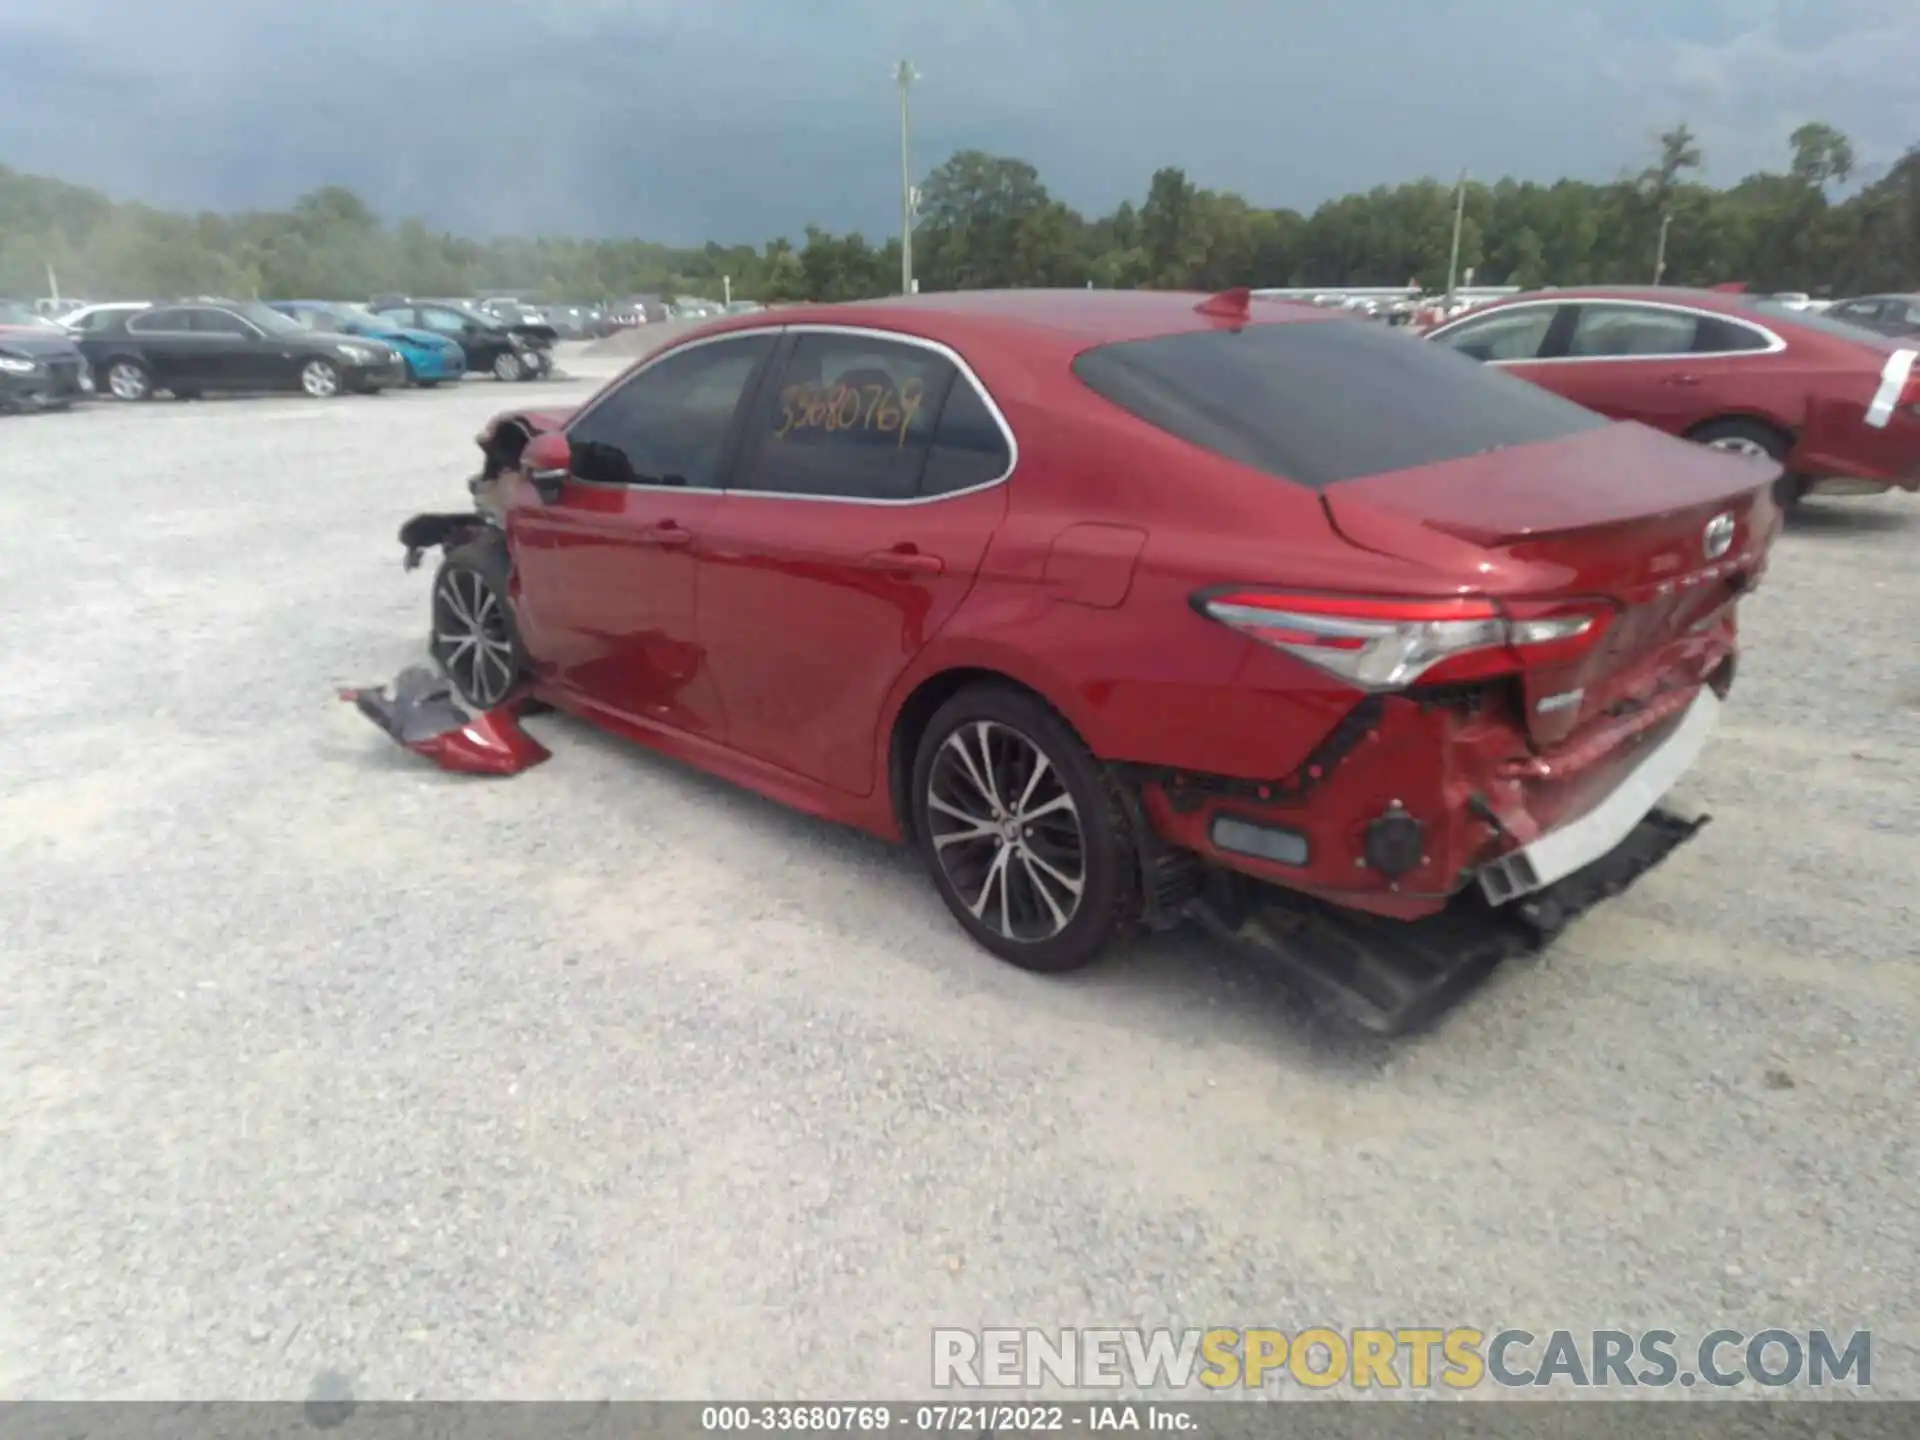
[{"left": 499, "top": 714, "right": 1466, "bottom": 1079}]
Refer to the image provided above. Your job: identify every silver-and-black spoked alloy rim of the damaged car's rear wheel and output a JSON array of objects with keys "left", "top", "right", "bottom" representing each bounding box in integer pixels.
[{"left": 927, "top": 720, "right": 1087, "bottom": 945}]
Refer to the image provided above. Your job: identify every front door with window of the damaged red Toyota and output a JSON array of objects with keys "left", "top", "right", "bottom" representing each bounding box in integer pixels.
[{"left": 507, "top": 332, "right": 778, "bottom": 739}]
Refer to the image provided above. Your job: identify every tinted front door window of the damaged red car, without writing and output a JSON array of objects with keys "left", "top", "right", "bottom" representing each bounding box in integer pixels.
[{"left": 566, "top": 334, "right": 776, "bottom": 490}]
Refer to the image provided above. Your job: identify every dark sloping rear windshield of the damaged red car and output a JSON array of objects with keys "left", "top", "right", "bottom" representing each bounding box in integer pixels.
[{"left": 1073, "top": 319, "right": 1607, "bottom": 490}]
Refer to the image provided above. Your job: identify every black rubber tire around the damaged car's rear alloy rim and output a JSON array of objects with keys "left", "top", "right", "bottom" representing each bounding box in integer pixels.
[{"left": 908, "top": 685, "right": 1139, "bottom": 973}]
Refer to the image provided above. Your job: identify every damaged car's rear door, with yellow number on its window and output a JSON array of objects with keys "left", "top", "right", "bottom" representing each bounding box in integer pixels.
[{"left": 699, "top": 326, "right": 1014, "bottom": 795}]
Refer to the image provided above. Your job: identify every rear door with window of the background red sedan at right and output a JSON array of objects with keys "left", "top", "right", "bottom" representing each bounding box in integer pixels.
[{"left": 1542, "top": 300, "right": 1780, "bottom": 434}]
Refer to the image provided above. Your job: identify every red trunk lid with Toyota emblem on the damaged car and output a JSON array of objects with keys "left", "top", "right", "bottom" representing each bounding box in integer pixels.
[{"left": 1321, "top": 424, "right": 1780, "bottom": 747}]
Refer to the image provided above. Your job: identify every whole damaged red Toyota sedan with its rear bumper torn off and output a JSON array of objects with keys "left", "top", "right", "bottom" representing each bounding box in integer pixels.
[{"left": 389, "top": 292, "right": 1780, "bottom": 1029}]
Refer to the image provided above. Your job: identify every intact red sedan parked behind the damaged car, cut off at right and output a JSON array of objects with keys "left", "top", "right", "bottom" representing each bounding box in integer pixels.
[{"left": 1427, "top": 288, "right": 1920, "bottom": 507}]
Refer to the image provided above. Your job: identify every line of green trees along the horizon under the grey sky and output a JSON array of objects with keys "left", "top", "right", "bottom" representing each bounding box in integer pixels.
[{"left": 0, "top": 123, "right": 1920, "bottom": 300}]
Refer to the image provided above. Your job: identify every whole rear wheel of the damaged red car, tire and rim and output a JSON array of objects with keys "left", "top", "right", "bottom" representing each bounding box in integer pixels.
[{"left": 912, "top": 685, "right": 1140, "bottom": 975}]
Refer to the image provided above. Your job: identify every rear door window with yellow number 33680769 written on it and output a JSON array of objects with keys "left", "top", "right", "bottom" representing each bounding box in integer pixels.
[{"left": 737, "top": 334, "right": 958, "bottom": 499}]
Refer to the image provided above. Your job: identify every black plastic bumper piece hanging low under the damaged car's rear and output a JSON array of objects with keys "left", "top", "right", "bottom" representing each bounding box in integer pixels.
[{"left": 1194, "top": 808, "right": 1707, "bottom": 1035}]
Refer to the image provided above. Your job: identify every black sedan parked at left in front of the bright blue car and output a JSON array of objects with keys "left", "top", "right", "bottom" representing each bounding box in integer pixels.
[{"left": 79, "top": 300, "right": 407, "bottom": 399}]
